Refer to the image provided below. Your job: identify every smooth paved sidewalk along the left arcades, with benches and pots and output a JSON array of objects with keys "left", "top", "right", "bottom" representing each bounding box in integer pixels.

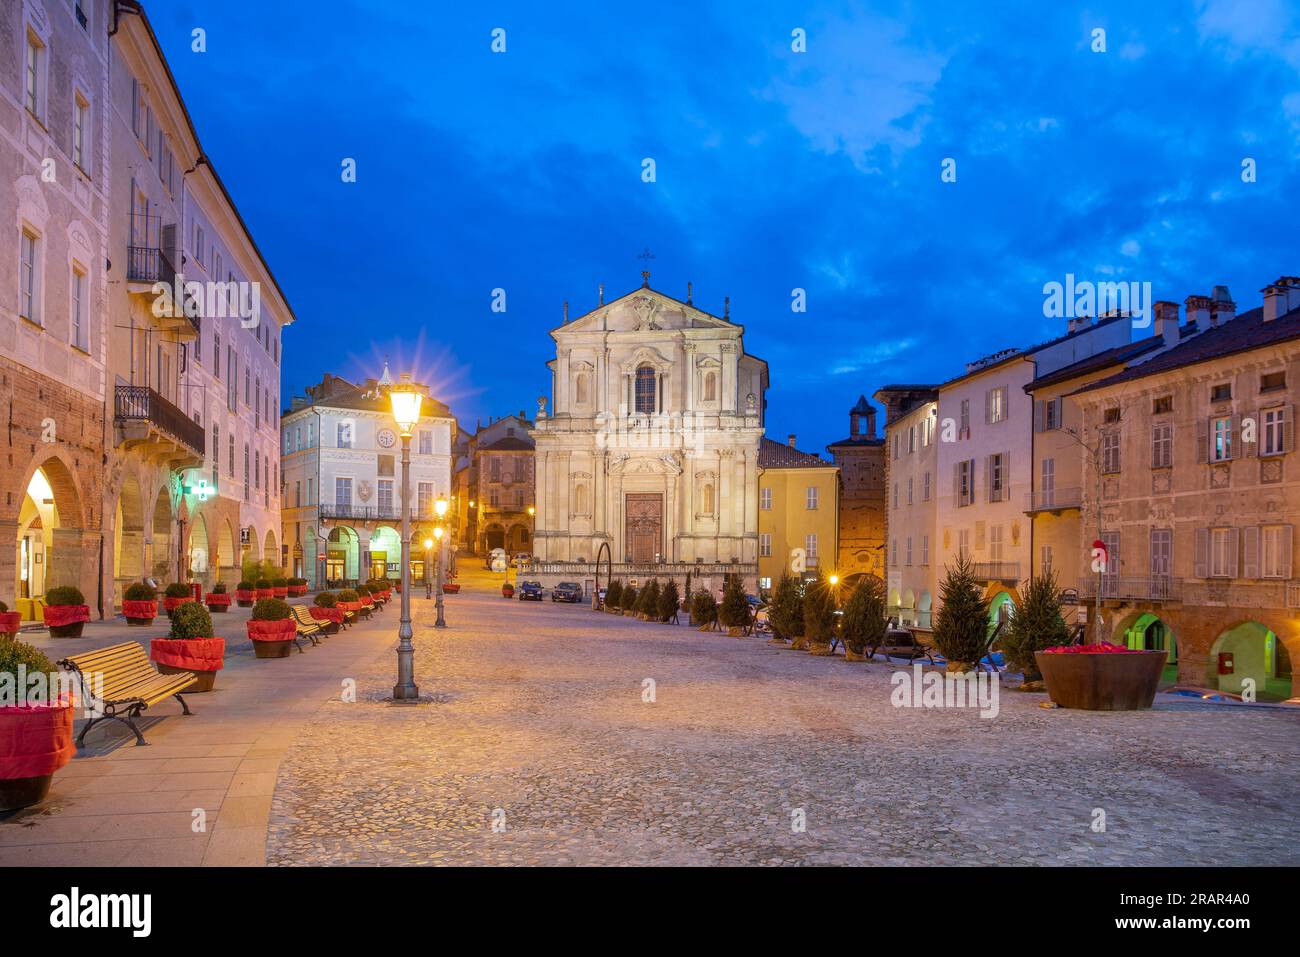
[{"left": 0, "top": 593, "right": 410, "bottom": 866}]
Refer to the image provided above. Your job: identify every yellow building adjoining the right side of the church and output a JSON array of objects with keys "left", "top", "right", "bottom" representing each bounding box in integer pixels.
[{"left": 758, "top": 436, "right": 840, "bottom": 589}]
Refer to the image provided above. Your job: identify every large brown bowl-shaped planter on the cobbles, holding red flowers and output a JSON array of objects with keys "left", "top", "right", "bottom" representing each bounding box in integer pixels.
[{"left": 1034, "top": 651, "right": 1167, "bottom": 711}]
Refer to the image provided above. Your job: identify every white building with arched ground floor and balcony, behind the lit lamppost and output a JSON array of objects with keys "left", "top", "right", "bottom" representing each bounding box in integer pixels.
[{"left": 281, "top": 367, "right": 458, "bottom": 588}]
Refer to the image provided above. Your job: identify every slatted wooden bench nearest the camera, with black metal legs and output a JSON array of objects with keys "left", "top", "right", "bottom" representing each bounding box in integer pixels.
[{"left": 59, "top": 641, "right": 194, "bottom": 748}]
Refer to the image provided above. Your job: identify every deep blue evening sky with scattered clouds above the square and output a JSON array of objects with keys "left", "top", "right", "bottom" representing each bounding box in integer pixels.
[{"left": 147, "top": 0, "right": 1300, "bottom": 451}]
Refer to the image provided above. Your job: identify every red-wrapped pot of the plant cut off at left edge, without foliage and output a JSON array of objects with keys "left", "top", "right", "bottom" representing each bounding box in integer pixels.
[{"left": 0, "top": 705, "right": 77, "bottom": 811}]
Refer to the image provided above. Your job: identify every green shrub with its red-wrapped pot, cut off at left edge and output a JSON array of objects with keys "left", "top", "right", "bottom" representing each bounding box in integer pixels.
[{"left": 0, "top": 638, "right": 77, "bottom": 811}]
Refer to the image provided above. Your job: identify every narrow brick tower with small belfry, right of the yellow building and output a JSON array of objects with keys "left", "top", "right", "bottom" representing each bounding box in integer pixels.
[{"left": 827, "top": 395, "right": 887, "bottom": 581}]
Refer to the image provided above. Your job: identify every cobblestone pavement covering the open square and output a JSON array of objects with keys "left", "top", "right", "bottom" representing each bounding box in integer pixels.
[{"left": 267, "top": 589, "right": 1300, "bottom": 865}]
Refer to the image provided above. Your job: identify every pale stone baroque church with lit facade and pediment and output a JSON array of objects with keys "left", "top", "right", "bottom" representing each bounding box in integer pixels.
[{"left": 532, "top": 272, "right": 768, "bottom": 589}]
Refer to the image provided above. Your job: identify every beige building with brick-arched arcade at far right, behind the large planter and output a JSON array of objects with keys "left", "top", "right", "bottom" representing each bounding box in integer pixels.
[{"left": 1069, "top": 277, "right": 1300, "bottom": 697}]
